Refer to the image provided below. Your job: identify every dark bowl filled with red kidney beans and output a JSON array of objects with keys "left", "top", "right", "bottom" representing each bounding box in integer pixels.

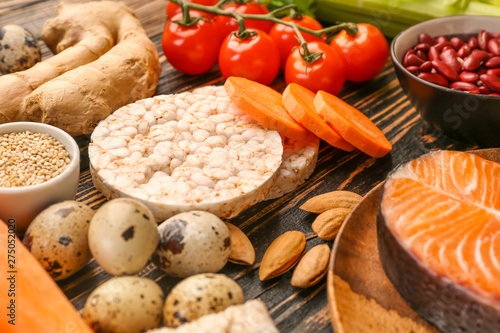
[{"left": 391, "top": 16, "right": 500, "bottom": 147}]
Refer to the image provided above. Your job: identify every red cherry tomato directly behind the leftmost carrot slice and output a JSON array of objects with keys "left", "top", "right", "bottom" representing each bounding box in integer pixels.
[{"left": 219, "top": 29, "right": 280, "bottom": 85}]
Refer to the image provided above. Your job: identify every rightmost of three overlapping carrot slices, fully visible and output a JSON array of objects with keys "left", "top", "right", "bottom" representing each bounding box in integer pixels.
[{"left": 314, "top": 90, "right": 392, "bottom": 157}]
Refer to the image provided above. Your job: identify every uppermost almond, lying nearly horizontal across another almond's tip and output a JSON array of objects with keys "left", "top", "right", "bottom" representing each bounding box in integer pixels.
[{"left": 300, "top": 191, "right": 362, "bottom": 214}]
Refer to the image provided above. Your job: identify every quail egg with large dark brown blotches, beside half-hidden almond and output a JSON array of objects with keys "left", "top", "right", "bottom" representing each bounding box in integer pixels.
[{"left": 152, "top": 211, "right": 231, "bottom": 277}]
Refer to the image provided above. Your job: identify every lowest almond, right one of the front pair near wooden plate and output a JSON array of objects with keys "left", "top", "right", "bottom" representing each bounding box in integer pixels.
[{"left": 291, "top": 244, "right": 331, "bottom": 288}]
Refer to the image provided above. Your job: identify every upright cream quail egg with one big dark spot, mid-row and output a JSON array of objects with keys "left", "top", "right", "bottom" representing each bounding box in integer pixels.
[{"left": 89, "top": 198, "right": 158, "bottom": 275}]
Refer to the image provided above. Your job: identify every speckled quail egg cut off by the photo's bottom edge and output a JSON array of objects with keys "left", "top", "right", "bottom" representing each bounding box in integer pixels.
[{"left": 83, "top": 276, "right": 164, "bottom": 333}]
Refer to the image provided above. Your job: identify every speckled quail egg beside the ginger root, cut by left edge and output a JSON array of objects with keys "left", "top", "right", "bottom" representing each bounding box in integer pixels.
[{"left": 0, "top": 24, "right": 42, "bottom": 74}]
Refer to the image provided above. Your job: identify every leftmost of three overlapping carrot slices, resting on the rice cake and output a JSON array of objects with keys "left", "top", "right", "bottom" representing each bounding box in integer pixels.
[{"left": 224, "top": 76, "right": 311, "bottom": 140}]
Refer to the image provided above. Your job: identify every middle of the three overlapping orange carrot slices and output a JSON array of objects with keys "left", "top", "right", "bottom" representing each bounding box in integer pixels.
[{"left": 283, "top": 83, "right": 355, "bottom": 151}]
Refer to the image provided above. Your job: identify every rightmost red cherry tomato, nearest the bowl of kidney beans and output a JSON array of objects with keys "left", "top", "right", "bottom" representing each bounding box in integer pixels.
[{"left": 330, "top": 23, "right": 389, "bottom": 82}]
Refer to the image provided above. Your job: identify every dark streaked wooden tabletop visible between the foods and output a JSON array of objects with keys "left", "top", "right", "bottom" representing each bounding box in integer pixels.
[{"left": 0, "top": 0, "right": 475, "bottom": 333}]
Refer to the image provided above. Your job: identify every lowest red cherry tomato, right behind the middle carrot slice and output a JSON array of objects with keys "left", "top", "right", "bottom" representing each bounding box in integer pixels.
[{"left": 285, "top": 42, "right": 346, "bottom": 95}]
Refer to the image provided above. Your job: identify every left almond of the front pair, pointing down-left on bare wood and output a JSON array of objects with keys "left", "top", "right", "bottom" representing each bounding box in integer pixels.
[{"left": 259, "top": 231, "right": 306, "bottom": 281}]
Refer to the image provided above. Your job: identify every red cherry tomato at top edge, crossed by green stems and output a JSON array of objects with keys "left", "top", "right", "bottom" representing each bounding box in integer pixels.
[{"left": 216, "top": 1, "right": 273, "bottom": 38}]
